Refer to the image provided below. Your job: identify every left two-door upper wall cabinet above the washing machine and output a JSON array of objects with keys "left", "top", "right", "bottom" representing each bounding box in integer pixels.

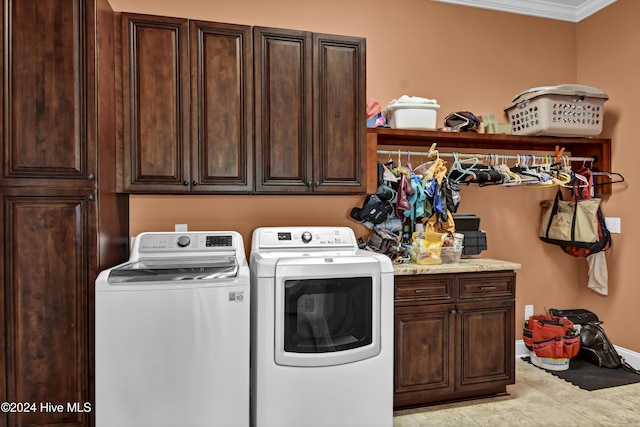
[{"left": 118, "top": 13, "right": 253, "bottom": 193}]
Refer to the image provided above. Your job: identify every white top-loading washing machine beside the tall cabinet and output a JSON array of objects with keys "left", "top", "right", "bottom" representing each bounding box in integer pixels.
[{"left": 95, "top": 231, "right": 250, "bottom": 427}]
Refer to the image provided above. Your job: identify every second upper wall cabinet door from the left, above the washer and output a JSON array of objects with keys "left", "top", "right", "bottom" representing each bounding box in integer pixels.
[{"left": 189, "top": 21, "right": 253, "bottom": 192}]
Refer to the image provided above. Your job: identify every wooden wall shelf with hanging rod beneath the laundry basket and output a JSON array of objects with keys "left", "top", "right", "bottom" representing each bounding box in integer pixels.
[{"left": 367, "top": 128, "right": 611, "bottom": 194}]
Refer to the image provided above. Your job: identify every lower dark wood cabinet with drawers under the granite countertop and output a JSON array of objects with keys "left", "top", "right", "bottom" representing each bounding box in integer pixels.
[{"left": 394, "top": 271, "right": 516, "bottom": 409}]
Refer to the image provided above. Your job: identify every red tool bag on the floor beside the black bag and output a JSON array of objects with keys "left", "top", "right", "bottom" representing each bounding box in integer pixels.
[{"left": 522, "top": 314, "right": 580, "bottom": 359}]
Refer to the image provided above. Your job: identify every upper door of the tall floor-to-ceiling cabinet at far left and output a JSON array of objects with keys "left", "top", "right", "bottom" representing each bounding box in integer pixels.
[{"left": 0, "top": 0, "right": 96, "bottom": 187}]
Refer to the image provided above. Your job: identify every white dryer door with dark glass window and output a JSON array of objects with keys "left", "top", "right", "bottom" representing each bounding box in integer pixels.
[{"left": 274, "top": 256, "right": 381, "bottom": 366}]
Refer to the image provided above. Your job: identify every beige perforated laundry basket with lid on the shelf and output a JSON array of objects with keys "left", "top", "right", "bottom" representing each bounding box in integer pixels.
[{"left": 504, "top": 85, "right": 609, "bottom": 137}]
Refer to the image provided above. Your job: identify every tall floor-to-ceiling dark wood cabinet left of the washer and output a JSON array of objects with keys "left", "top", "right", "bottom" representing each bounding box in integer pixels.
[{"left": 0, "top": 0, "right": 128, "bottom": 426}]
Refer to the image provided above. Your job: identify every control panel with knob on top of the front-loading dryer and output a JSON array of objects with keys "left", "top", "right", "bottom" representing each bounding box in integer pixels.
[{"left": 253, "top": 227, "right": 357, "bottom": 249}]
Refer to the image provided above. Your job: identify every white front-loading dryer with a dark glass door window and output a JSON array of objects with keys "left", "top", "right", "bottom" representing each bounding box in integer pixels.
[{"left": 250, "top": 227, "right": 394, "bottom": 427}]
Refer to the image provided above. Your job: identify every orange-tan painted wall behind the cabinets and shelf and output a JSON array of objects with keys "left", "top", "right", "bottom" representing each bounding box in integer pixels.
[{"left": 110, "top": 0, "right": 640, "bottom": 351}]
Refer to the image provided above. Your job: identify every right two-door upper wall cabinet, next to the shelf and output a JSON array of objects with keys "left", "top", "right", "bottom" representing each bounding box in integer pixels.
[{"left": 254, "top": 27, "right": 366, "bottom": 194}]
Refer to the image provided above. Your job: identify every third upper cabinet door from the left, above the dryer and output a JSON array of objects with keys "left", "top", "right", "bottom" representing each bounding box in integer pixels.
[{"left": 253, "top": 27, "right": 313, "bottom": 193}]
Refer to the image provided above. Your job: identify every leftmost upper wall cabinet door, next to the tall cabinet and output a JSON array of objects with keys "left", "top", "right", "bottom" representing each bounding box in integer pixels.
[{"left": 122, "top": 13, "right": 190, "bottom": 192}]
